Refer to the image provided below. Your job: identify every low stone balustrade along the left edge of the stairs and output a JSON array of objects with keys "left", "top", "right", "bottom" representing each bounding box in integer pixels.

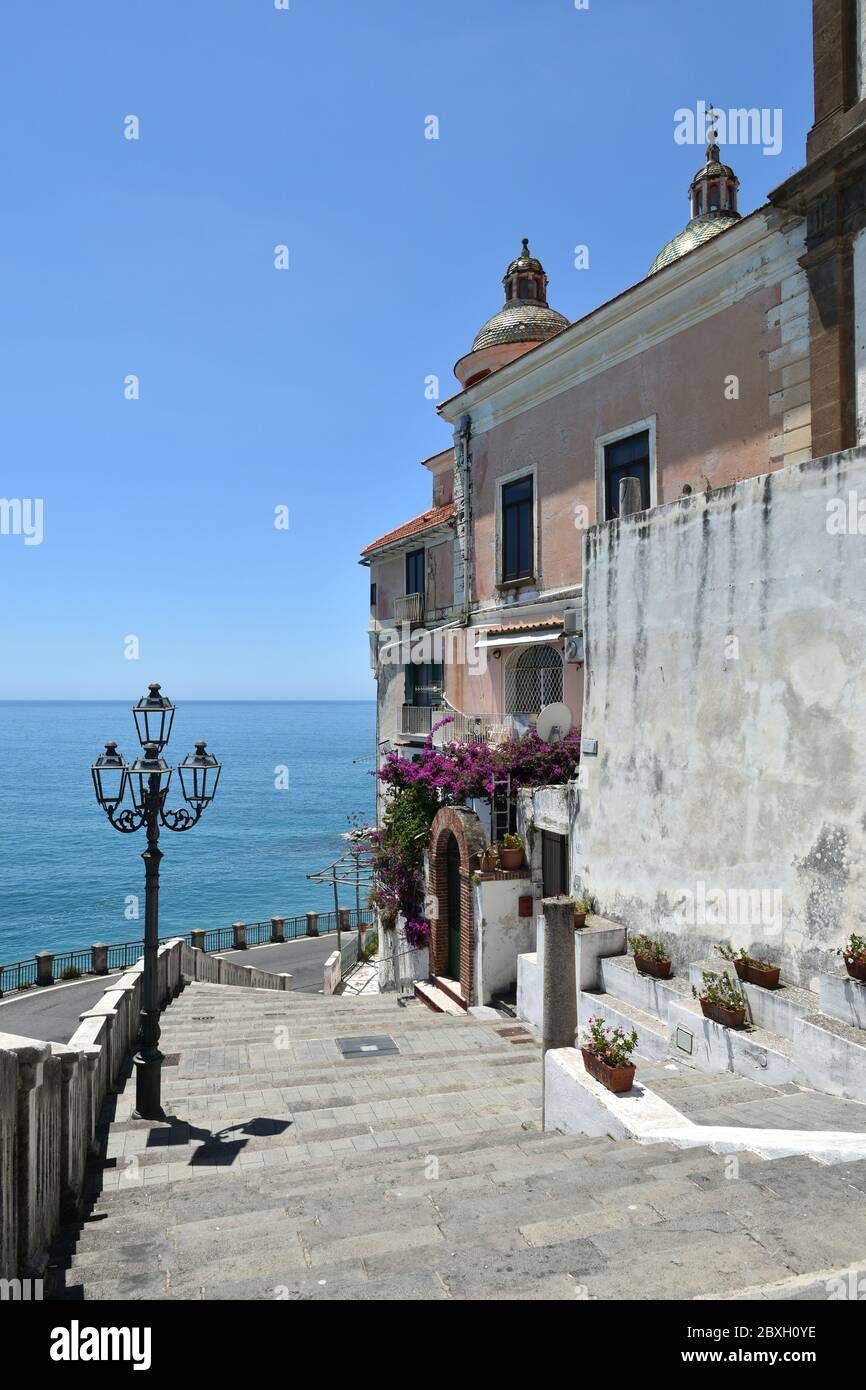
[{"left": 0, "top": 940, "right": 292, "bottom": 1279}]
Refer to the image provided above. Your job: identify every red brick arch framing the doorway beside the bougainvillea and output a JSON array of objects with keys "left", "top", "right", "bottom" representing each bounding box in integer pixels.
[{"left": 430, "top": 806, "right": 487, "bottom": 1004}]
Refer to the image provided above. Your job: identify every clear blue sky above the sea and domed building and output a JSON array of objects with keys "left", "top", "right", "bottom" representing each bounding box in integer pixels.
[{"left": 0, "top": 0, "right": 812, "bottom": 699}]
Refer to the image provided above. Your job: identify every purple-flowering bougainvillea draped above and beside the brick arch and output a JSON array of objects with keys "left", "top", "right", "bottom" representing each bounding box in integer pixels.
[{"left": 370, "top": 717, "right": 580, "bottom": 945}]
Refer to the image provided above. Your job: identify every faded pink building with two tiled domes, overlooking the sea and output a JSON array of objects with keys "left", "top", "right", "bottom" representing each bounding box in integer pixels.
[{"left": 363, "top": 136, "right": 812, "bottom": 756}]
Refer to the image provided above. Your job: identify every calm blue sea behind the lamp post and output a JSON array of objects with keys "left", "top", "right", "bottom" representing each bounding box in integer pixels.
[{"left": 0, "top": 701, "right": 375, "bottom": 963}]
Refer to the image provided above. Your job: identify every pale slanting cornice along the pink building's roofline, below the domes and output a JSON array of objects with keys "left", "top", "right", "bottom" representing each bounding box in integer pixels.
[{"left": 439, "top": 206, "right": 803, "bottom": 435}]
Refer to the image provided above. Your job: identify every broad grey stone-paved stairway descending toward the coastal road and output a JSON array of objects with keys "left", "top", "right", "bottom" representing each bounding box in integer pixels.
[{"left": 51, "top": 980, "right": 866, "bottom": 1300}]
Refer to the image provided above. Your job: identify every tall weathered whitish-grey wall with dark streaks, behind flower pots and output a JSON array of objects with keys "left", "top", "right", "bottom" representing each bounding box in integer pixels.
[{"left": 573, "top": 449, "right": 866, "bottom": 983}]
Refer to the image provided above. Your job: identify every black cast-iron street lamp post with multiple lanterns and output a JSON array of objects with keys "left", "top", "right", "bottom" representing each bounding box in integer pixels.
[{"left": 90, "top": 684, "right": 221, "bottom": 1120}]
